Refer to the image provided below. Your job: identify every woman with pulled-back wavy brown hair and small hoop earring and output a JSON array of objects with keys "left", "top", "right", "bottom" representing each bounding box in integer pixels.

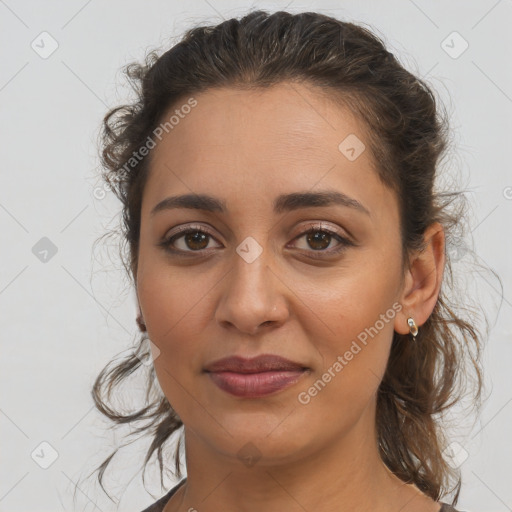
[{"left": 93, "top": 11, "right": 481, "bottom": 512}]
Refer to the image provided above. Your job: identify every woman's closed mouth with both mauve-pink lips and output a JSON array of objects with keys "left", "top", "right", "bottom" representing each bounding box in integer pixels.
[{"left": 205, "top": 354, "right": 310, "bottom": 398}]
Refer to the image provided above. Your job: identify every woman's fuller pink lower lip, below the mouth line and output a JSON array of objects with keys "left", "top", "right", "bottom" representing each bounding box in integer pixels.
[{"left": 208, "top": 370, "right": 306, "bottom": 398}]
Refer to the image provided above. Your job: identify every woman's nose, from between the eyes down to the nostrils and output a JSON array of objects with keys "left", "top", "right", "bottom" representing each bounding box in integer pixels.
[{"left": 216, "top": 237, "right": 287, "bottom": 334}]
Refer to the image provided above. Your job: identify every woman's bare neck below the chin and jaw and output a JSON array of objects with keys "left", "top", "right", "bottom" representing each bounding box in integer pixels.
[{"left": 165, "top": 400, "right": 425, "bottom": 512}]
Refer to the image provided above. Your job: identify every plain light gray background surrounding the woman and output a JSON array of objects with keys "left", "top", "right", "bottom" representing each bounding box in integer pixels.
[{"left": 0, "top": 0, "right": 512, "bottom": 512}]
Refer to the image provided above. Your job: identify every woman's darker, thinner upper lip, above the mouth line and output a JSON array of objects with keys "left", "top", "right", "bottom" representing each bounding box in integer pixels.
[{"left": 205, "top": 354, "right": 306, "bottom": 373}]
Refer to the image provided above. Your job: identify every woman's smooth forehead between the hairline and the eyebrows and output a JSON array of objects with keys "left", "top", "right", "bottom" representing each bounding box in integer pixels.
[{"left": 143, "top": 83, "right": 396, "bottom": 220}]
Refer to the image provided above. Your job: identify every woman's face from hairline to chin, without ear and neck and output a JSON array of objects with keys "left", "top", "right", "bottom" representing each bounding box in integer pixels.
[{"left": 136, "top": 83, "right": 402, "bottom": 464}]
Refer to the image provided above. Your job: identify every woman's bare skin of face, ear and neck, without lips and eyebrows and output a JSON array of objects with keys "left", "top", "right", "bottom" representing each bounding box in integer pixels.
[{"left": 136, "top": 83, "right": 444, "bottom": 512}]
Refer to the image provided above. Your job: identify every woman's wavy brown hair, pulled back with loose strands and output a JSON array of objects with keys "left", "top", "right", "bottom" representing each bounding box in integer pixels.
[{"left": 92, "top": 11, "right": 488, "bottom": 504}]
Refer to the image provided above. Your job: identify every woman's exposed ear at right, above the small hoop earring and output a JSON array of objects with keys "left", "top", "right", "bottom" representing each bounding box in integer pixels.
[{"left": 394, "top": 222, "right": 445, "bottom": 334}]
